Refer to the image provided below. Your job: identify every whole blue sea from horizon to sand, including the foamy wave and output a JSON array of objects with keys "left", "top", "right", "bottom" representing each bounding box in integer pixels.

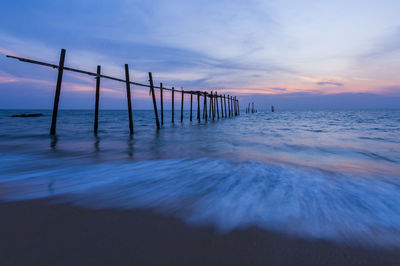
[{"left": 0, "top": 110, "right": 400, "bottom": 247}]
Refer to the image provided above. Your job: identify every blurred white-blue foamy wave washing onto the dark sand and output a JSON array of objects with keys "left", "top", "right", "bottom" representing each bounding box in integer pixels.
[{"left": 0, "top": 155, "right": 400, "bottom": 246}]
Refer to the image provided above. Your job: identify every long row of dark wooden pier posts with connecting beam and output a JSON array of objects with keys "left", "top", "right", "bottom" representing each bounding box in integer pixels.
[{"left": 7, "top": 49, "right": 240, "bottom": 135}]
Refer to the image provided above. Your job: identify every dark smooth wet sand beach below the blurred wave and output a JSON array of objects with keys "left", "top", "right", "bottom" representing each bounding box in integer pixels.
[{"left": 0, "top": 200, "right": 400, "bottom": 265}]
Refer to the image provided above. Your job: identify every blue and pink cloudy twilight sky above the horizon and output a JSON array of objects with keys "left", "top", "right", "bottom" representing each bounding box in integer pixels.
[{"left": 0, "top": 0, "right": 400, "bottom": 109}]
